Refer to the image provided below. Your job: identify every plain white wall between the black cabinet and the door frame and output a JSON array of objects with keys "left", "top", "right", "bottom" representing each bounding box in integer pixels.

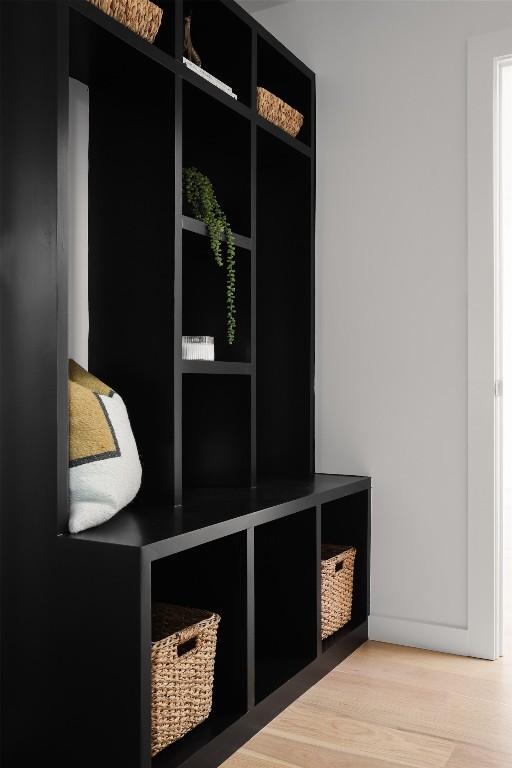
[{"left": 256, "top": 0, "right": 512, "bottom": 652}]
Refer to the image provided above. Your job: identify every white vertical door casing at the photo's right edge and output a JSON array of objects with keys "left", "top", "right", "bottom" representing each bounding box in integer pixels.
[{"left": 467, "top": 25, "right": 512, "bottom": 659}]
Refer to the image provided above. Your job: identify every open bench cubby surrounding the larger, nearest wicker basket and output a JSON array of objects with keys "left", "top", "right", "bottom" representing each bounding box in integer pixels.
[{"left": 151, "top": 532, "right": 247, "bottom": 768}]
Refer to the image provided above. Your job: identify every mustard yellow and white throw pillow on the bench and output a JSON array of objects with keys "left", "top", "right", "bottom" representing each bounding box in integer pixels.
[{"left": 68, "top": 360, "right": 142, "bottom": 533}]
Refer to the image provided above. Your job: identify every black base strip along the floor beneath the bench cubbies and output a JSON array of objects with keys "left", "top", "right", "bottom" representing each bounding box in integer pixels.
[{"left": 153, "top": 620, "right": 368, "bottom": 768}]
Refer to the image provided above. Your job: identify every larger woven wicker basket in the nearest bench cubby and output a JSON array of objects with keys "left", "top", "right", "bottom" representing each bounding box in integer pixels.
[{"left": 151, "top": 603, "right": 220, "bottom": 755}]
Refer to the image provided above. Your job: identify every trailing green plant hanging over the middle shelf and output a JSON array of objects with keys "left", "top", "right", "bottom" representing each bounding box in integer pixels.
[{"left": 183, "top": 168, "right": 236, "bottom": 344}]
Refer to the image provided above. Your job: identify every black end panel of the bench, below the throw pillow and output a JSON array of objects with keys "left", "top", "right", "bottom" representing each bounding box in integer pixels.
[{"left": 56, "top": 539, "right": 151, "bottom": 768}]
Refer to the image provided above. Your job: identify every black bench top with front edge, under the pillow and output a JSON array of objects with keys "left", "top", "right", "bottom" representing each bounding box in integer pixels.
[{"left": 62, "top": 474, "right": 370, "bottom": 560}]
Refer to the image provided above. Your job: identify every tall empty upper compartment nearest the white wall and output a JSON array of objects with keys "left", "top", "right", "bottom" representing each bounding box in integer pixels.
[{"left": 256, "top": 130, "right": 314, "bottom": 478}]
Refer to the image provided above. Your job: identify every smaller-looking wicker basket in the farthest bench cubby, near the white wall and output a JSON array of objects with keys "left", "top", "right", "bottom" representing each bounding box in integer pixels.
[{"left": 322, "top": 544, "right": 356, "bottom": 640}]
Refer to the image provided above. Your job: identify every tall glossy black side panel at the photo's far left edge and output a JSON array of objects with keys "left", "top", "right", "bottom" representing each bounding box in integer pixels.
[{"left": 0, "top": 2, "right": 62, "bottom": 768}]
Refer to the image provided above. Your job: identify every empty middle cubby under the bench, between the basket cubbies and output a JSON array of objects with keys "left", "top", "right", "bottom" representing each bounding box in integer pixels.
[{"left": 254, "top": 509, "right": 317, "bottom": 702}]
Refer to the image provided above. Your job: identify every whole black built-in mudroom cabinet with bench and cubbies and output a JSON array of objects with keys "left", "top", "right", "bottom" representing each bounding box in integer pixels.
[{"left": 0, "top": 0, "right": 370, "bottom": 768}]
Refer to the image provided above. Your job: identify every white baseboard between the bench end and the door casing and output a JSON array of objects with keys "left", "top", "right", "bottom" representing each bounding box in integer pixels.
[{"left": 368, "top": 615, "right": 471, "bottom": 656}]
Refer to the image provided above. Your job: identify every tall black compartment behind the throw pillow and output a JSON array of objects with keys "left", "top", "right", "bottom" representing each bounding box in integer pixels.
[{"left": 69, "top": 10, "right": 174, "bottom": 502}]
